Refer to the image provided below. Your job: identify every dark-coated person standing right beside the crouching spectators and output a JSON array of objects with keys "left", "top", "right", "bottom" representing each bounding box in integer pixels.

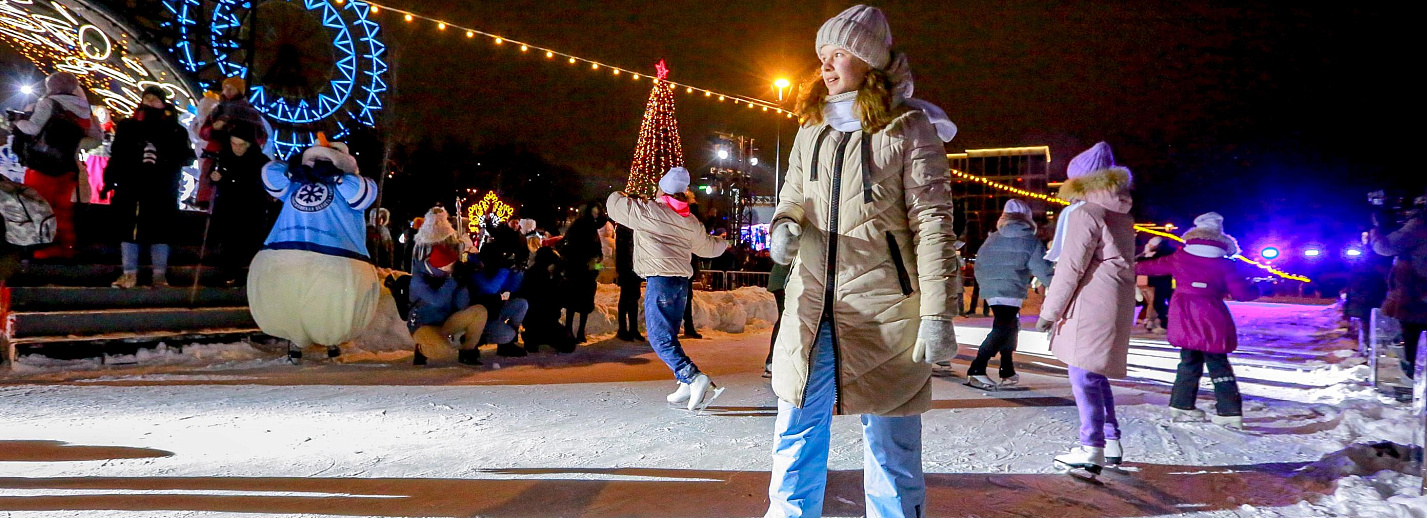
[{"left": 559, "top": 203, "right": 605, "bottom": 344}]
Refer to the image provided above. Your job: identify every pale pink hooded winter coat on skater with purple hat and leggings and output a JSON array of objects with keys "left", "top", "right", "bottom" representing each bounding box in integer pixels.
[{"left": 1040, "top": 170, "right": 1134, "bottom": 378}]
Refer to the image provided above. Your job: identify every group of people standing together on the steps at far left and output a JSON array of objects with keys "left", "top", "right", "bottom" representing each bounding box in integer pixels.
[{"left": 7, "top": 71, "right": 277, "bottom": 288}]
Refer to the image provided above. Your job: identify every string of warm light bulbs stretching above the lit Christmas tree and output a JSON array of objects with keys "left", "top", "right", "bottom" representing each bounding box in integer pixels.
[{"left": 343, "top": 0, "right": 793, "bottom": 118}]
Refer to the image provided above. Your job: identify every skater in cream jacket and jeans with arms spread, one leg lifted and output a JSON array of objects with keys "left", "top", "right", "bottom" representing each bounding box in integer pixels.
[{"left": 605, "top": 167, "right": 728, "bottom": 410}]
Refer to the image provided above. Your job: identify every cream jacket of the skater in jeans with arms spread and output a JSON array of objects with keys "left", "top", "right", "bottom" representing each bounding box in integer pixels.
[{"left": 605, "top": 193, "right": 728, "bottom": 278}]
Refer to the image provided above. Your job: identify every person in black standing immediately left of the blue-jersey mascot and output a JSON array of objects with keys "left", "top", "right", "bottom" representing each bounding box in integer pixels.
[{"left": 208, "top": 121, "right": 274, "bottom": 285}]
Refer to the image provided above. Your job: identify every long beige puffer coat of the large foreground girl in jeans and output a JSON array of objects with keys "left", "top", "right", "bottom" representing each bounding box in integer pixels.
[{"left": 773, "top": 111, "right": 960, "bottom": 415}]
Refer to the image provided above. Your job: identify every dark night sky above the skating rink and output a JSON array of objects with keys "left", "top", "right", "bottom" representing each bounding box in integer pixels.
[{"left": 381, "top": 0, "right": 1421, "bottom": 249}]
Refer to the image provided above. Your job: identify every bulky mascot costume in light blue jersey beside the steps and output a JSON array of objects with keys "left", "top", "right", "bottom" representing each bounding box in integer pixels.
[{"left": 248, "top": 138, "right": 381, "bottom": 360}]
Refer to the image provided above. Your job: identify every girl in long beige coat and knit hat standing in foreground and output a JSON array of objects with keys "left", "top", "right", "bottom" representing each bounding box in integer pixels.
[{"left": 768, "top": 6, "right": 960, "bottom": 517}]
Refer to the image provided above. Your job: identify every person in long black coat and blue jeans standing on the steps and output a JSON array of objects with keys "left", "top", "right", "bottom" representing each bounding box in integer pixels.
[{"left": 104, "top": 87, "right": 194, "bottom": 288}]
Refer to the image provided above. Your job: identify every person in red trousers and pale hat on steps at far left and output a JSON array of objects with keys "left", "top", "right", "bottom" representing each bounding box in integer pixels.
[{"left": 14, "top": 71, "right": 103, "bottom": 260}]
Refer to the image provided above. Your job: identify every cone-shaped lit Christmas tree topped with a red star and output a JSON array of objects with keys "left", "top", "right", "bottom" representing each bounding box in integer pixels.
[{"left": 625, "top": 60, "right": 684, "bottom": 197}]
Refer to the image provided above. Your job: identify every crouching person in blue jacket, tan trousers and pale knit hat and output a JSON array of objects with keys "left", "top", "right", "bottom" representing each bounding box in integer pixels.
[{"left": 407, "top": 245, "right": 488, "bottom": 365}]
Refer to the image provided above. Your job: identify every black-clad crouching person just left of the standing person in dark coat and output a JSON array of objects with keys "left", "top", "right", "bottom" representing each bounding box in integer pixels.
[{"left": 517, "top": 247, "right": 575, "bottom": 352}]
